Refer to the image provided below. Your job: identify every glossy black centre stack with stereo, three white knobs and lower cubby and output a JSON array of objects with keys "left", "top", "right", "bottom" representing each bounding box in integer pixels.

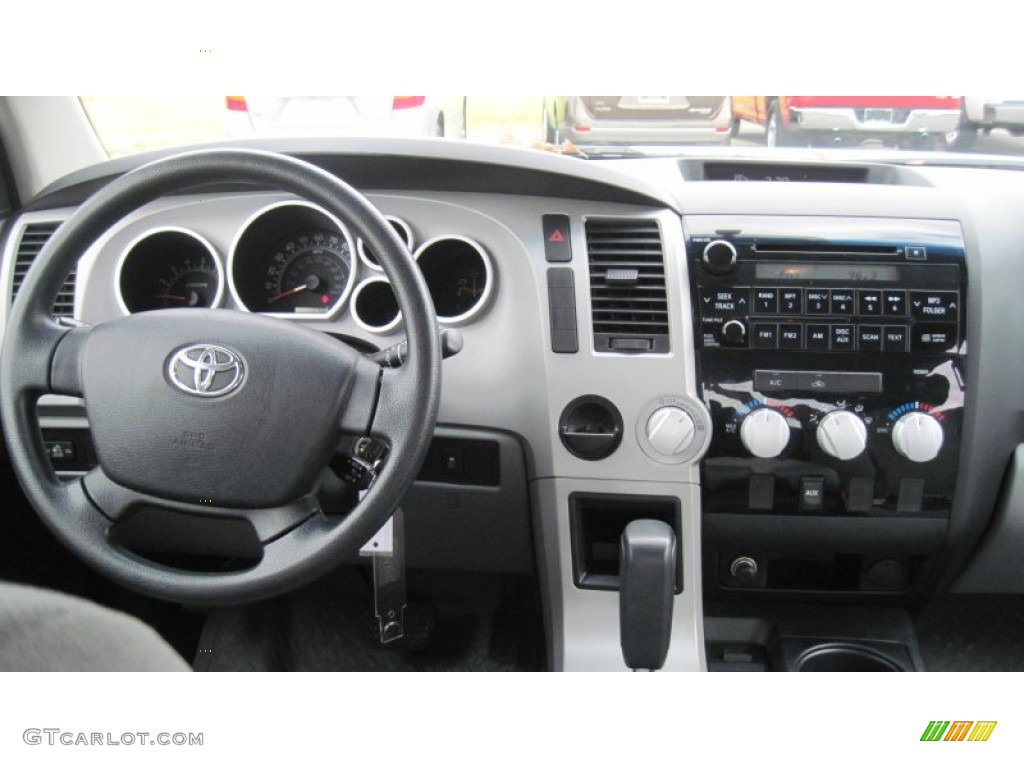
[{"left": 684, "top": 215, "right": 967, "bottom": 603}]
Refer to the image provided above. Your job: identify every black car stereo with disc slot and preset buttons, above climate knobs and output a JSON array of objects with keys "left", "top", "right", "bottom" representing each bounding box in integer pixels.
[{"left": 689, "top": 217, "right": 966, "bottom": 353}]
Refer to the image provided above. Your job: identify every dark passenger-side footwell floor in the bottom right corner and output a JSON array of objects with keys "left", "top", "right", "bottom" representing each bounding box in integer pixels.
[{"left": 915, "top": 595, "right": 1024, "bottom": 672}]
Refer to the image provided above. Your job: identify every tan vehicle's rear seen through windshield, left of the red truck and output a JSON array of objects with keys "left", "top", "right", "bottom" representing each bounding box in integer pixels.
[{"left": 544, "top": 96, "right": 732, "bottom": 146}]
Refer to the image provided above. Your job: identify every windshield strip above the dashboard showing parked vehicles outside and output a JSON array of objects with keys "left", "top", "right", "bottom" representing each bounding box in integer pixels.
[{"left": 81, "top": 95, "right": 1024, "bottom": 158}]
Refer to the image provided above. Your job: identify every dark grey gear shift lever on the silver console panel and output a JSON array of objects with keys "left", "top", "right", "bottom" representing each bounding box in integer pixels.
[{"left": 618, "top": 520, "right": 676, "bottom": 670}]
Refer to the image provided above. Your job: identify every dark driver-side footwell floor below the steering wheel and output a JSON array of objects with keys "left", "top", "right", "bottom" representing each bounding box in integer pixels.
[{"left": 195, "top": 569, "right": 543, "bottom": 672}]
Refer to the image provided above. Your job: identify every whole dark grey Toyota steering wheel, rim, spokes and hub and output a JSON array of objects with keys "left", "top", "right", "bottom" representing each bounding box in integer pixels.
[{"left": 0, "top": 150, "right": 441, "bottom": 604}]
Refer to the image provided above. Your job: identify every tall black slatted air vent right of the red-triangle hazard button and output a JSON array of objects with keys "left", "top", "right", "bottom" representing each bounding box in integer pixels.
[{"left": 587, "top": 219, "right": 669, "bottom": 353}]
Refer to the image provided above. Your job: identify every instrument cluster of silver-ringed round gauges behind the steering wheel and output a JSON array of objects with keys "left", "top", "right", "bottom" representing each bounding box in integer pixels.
[{"left": 116, "top": 201, "right": 495, "bottom": 335}]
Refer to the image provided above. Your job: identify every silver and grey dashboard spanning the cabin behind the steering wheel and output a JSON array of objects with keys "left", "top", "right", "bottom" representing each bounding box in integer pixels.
[{"left": 0, "top": 140, "right": 1024, "bottom": 670}]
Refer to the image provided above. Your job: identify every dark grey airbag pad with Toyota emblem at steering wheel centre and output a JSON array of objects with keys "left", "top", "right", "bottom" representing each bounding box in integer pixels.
[{"left": 80, "top": 309, "right": 379, "bottom": 508}]
